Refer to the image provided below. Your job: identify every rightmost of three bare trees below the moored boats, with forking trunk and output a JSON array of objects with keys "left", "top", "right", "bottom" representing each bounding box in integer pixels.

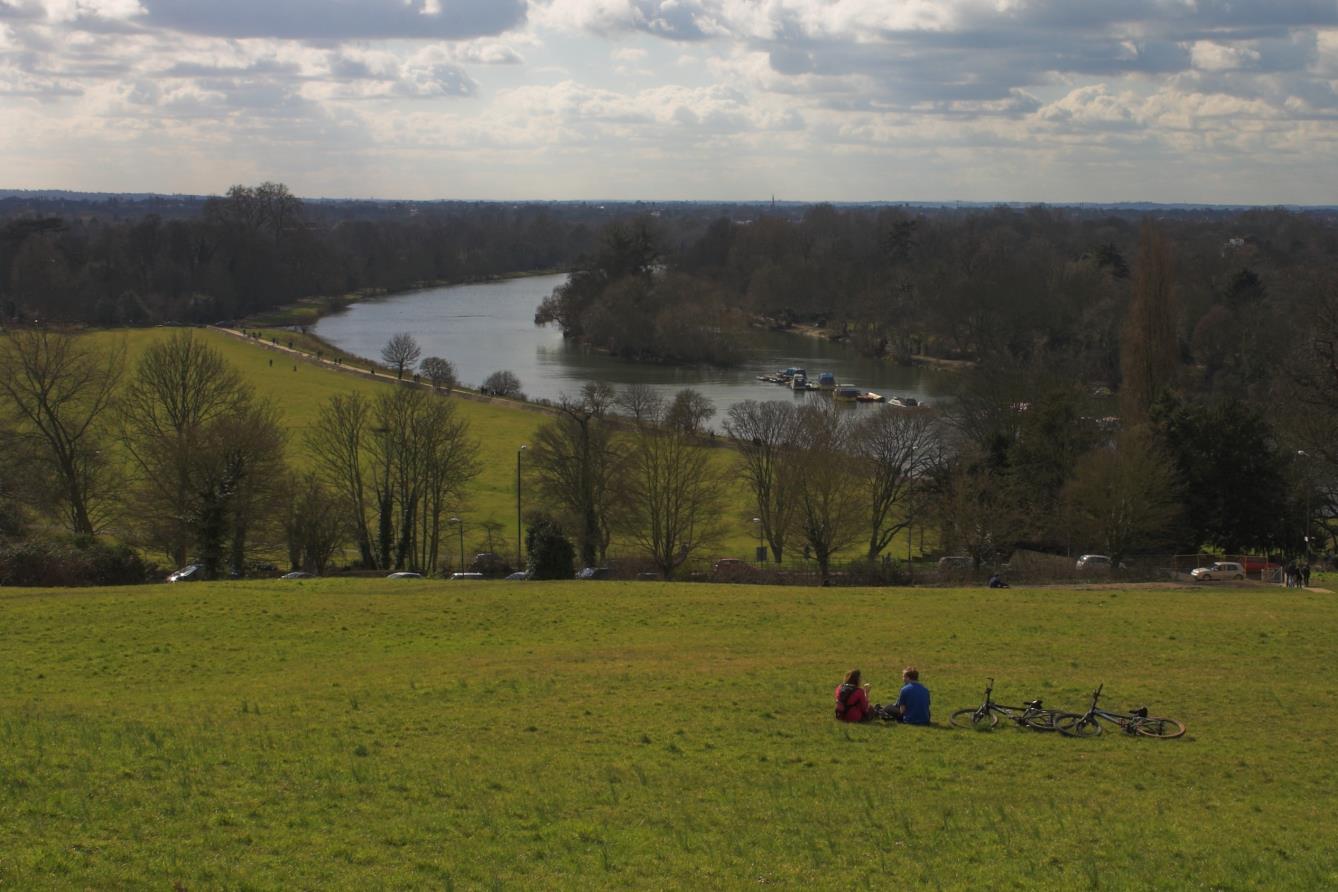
[{"left": 854, "top": 408, "right": 942, "bottom": 560}]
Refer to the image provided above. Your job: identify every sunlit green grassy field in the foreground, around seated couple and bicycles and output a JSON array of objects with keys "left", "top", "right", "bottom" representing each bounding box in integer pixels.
[{"left": 0, "top": 580, "right": 1338, "bottom": 889}]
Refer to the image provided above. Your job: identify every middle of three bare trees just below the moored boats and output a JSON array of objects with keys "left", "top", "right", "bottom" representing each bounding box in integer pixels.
[{"left": 793, "top": 403, "right": 866, "bottom": 583}]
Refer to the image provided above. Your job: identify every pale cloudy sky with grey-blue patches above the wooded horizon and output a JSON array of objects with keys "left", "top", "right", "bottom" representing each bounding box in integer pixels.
[{"left": 0, "top": 0, "right": 1338, "bottom": 205}]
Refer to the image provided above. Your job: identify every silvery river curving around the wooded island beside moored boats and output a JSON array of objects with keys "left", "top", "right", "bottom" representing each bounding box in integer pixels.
[{"left": 314, "top": 275, "right": 949, "bottom": 428}]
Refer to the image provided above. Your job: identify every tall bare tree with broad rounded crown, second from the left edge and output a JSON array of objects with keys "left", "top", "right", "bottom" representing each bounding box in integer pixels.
[{"left": 122, "top": 332, "right": 253, "bottom": 566}]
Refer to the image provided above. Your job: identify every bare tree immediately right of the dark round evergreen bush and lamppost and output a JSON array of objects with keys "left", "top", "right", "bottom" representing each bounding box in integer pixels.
[{"left": 529, "top": 384, "right": 619, "bottom": 566}]
